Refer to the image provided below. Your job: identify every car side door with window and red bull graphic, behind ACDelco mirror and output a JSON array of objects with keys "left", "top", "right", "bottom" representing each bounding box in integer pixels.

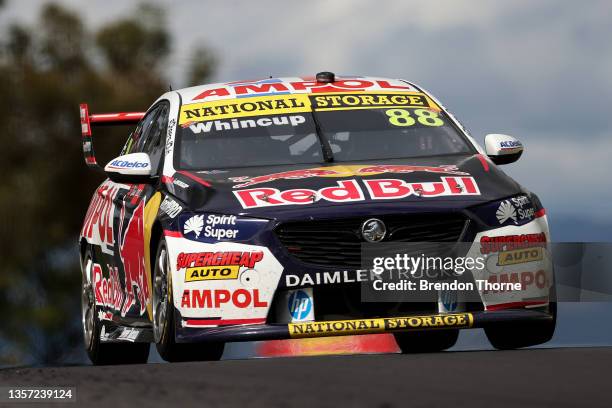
[{"left": 113, "top": 102, "right": 169, "bottom": 321}]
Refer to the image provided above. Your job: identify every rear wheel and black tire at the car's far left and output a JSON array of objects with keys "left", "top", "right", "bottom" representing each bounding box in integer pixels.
[{"left": 81, "top": 248, "right": 151, "bottom": 365}]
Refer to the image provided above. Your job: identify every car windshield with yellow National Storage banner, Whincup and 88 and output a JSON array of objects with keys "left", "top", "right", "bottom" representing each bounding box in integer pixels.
[{"left": 175, "top": 93, "right": 473, "bottom": 170}]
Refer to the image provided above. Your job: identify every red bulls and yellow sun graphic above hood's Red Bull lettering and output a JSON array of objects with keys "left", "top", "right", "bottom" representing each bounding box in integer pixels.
[{"left": 230, "top": 164, "right": 469, "bottom": 188}]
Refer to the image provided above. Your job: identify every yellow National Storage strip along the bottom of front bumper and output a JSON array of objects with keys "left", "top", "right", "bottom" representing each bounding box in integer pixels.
[{"left": 288, "top": 313, "right": 474, "bottom": 338}]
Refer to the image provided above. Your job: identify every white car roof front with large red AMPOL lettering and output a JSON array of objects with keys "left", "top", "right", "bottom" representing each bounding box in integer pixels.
[{"left": 176, "top": 74, "right": 420, "bottom": 104}]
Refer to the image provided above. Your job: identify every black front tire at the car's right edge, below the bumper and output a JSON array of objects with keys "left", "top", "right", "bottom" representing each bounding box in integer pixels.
[{"left": 484, "top": 298, "right": 557, "bottom": 350}]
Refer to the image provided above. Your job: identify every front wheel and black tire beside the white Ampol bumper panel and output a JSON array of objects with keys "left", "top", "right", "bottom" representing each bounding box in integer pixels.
[{"left": 151, "top": 237, "right": 225, "bottom": 362}]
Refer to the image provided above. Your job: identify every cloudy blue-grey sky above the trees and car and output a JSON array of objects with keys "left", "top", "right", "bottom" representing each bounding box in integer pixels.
[{"left": 0, "top": 0, "right": 612, "bottom": 238}]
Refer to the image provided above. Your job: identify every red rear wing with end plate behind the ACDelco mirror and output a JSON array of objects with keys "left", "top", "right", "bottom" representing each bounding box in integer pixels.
[{"left": 79, "top": 103, "right": 145, "bottom": 168}]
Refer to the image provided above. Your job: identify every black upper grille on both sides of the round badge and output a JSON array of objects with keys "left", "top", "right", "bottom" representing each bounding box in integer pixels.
[{"left": 275, "top": 214, "right": 467, "bottom": 268}]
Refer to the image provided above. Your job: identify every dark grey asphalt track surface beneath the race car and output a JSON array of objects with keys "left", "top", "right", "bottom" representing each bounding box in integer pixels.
[{"left": 0, "top": 348, "right": 612, "bottom": 408}]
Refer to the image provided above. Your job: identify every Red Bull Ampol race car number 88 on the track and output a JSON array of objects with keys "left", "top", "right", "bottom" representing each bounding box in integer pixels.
[{"left": 79, "top": 72, "right": 556, "bottom": 364}]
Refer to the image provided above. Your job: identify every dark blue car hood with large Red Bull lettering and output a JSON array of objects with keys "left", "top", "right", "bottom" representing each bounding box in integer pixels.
[{"left": 173, "top": 154, "right": 521, "bottom": 219}]
